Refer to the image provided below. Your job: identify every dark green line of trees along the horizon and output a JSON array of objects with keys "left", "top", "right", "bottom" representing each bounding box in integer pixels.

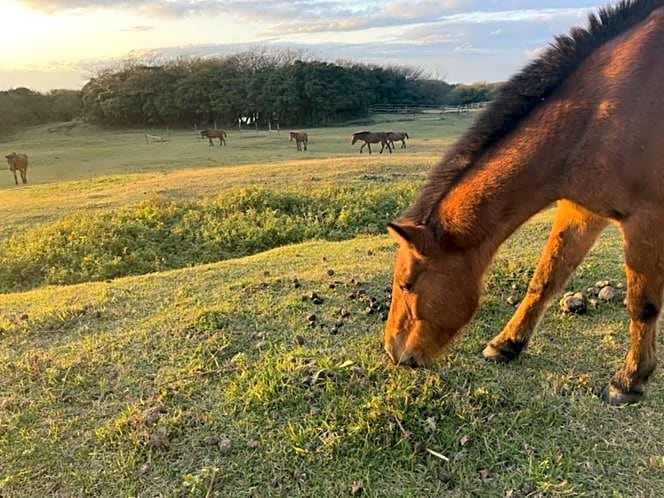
[{"left": 0, "top": 51, "right": 497, "bottom": 133}]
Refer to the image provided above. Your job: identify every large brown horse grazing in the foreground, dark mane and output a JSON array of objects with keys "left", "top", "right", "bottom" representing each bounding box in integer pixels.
[{"left": 385, "top": 0, "right": 664, "bottom": 404}]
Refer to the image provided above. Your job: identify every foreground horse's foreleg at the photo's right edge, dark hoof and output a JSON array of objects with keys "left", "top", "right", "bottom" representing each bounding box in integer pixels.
[{"left": 604, "top": 215, "right": 664, "bottom": 404}]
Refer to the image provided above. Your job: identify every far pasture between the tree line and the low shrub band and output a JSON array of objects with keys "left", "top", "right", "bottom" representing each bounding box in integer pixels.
[{"left": 0, "top": 114, "right": 473, "bottom": 240}]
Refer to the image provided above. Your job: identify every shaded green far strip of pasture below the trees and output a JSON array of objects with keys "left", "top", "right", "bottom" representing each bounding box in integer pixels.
[{"left": 0, "top": 114, "right": 474, "bottom": 185}]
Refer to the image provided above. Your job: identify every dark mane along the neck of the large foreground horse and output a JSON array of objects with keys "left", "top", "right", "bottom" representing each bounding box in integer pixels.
[{"left": 403, "top": 0, "right": 664, "bottom": 224}]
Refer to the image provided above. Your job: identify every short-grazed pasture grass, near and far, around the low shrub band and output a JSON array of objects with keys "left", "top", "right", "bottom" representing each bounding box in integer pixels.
[{"left": 0, "top": 118, "right": 664, "bottom": 497}]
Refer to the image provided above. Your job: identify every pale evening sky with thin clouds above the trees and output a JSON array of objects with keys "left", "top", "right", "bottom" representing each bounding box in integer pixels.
[{"left": 0, "top": 0, "right": 615, "bottom": 91}]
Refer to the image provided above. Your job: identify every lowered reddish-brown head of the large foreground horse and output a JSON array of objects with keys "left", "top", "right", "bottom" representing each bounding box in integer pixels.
[{"left": 385, "top": 221, "right": 482, "bottom": 366}]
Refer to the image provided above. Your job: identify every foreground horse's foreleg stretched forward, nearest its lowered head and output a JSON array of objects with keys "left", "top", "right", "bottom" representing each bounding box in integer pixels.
[{"left": 482, "top": 201, "right": 608, "bottom": 362}]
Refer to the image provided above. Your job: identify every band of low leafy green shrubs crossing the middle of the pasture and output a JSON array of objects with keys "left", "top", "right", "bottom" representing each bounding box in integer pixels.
[{"left": 0, "top": 182, "right": 418, "bottom": 292}]
